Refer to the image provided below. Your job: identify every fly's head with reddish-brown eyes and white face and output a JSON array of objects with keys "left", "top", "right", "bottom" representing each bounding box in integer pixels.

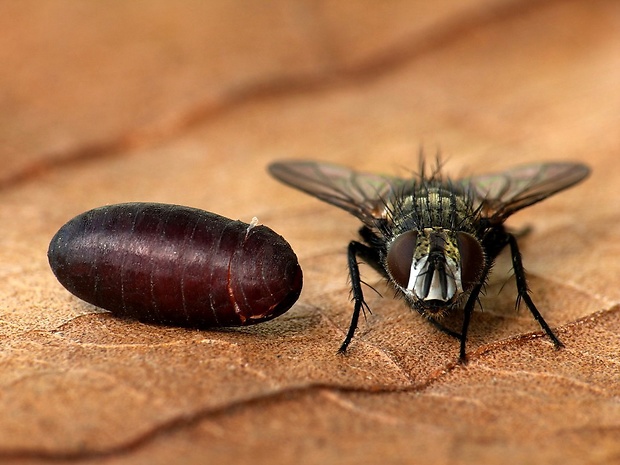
[{"left": 386, "top": 228, "right": 484, "bottom": 312}]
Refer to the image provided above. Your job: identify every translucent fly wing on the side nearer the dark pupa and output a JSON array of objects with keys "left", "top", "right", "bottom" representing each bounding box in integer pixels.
[{"left": 269, "top": 160, "right": 405, "bottom": 226}]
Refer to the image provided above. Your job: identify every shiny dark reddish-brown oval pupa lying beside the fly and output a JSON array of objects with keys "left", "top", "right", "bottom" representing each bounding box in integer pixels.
[{"left": 48, "top": 203, "right": 303, "bottom": 328}]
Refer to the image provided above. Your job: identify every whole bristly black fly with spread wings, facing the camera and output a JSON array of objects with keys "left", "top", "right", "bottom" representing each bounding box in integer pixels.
[{"left": 269, "top": 159, "right": 590, "bottom": 361}]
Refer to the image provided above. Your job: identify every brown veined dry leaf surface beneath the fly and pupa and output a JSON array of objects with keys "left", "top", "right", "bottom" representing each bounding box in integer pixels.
[{"left": 0, "top": 0, "right": 620, "bottom": 464}]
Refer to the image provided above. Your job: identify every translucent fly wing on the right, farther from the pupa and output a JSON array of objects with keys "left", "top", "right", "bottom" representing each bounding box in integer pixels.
[{"left": 457, "top": 163, "right": 590, "bottom": 224}]
